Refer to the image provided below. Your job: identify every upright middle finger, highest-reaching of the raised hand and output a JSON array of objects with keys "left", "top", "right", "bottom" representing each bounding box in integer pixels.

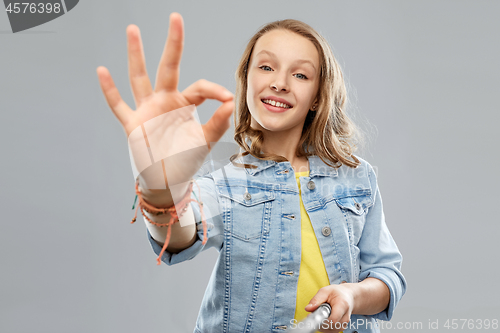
[{"left": 155, "top": 13, "right": 184, "bottom": 91}]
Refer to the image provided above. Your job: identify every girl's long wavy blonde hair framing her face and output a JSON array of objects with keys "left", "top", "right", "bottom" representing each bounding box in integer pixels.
[{"left": 230, "top": 19, "right": 362, "bottom": 168}]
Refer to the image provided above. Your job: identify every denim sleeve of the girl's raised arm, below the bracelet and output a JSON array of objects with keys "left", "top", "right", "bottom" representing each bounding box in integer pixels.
[{"left": 146, "top": 174, "right": 224, "bottom": 266}]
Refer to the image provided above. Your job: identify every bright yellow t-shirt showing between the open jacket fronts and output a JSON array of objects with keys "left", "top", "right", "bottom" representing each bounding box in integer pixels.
[{"left": 294, "top": 171, "right": 342, "bottom": 333}]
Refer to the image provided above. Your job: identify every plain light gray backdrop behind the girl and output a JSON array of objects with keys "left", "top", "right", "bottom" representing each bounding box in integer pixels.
[{"left": 0, "top": 0, "right": 500, "bottom": 333}]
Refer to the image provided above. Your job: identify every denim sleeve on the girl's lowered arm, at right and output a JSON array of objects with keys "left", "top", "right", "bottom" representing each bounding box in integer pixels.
[{"left": 358, "top": 164, "right": 406, "bottom": 321}]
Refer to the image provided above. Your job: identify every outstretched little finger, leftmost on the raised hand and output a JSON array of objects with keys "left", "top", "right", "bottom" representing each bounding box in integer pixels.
[{"left": 97, "top": 66, "right": 133, "bottom": 125}]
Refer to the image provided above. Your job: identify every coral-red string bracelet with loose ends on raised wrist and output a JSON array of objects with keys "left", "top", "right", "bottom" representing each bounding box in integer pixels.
[{"left": 130, "top": 179, "right": 207, "bottom": 265}]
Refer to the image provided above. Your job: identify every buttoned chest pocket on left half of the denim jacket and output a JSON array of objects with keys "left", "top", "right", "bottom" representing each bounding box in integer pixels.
[{"left": 217, "top": 185, "right": 275, "bottom": 241}]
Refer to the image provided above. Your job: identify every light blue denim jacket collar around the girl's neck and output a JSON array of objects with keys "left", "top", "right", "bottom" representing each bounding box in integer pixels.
[{"left": 238, "top": 139, "right": 338, "bottom": 178}]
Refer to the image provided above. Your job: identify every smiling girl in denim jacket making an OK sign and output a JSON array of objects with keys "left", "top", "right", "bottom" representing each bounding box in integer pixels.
[{"left": 97, "top": 13, "right": 406, "bottom": 332}]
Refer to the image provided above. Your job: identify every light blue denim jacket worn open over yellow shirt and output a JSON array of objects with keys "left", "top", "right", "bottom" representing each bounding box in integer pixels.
[{"left": 148, "top": 149, "right": 406, "bottom": 333}]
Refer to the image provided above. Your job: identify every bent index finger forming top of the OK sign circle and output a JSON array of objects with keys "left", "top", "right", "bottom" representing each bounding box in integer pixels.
[{"left": 182, "top": 79, "right": 234, "bottom": 106}]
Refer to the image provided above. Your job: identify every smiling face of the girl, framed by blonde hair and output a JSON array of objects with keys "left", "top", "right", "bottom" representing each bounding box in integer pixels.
[{"left": 246, "top": 30, "right": 320, "bottom": 135}]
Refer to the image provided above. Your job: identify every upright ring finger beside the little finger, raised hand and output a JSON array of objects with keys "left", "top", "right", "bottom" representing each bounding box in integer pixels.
[{"left": 127, "top": 24, "right": 153, "bottom": 107}]
